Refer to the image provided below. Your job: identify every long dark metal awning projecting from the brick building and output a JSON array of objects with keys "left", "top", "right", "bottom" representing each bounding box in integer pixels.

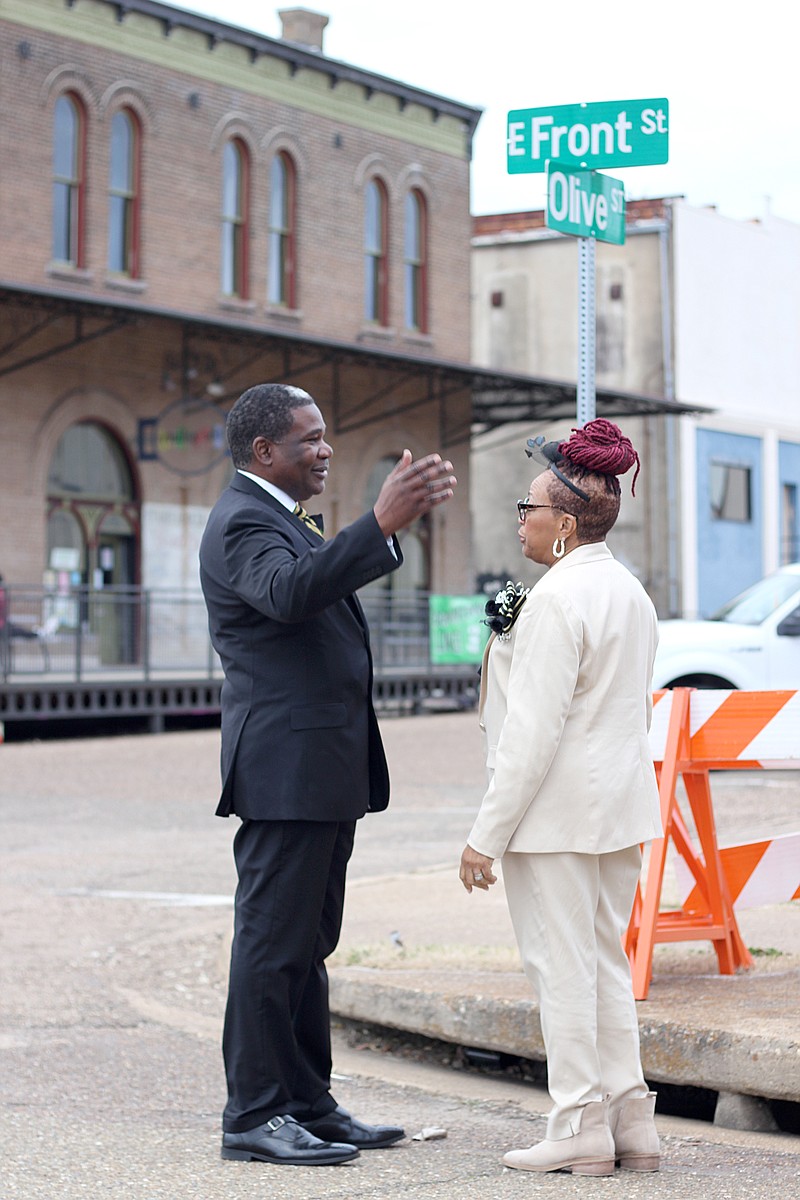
[{"left": 0, "top": 281, "right": 708, "bottom": 446}]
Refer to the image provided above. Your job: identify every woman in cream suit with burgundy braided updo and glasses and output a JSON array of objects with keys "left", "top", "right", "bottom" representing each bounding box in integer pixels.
[{"left": 461, "top": 419, "right": 662, "bottom": 1175}]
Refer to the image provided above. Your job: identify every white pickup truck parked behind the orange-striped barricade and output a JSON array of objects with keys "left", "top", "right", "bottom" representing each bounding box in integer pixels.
[{"left": 652, "top": 563, "right": 800, "bottom": 691}]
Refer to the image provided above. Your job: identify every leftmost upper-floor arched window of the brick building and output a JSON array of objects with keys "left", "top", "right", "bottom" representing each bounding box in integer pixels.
[{"left": 53, "top": 92, "right": 86, "bottom": 266}]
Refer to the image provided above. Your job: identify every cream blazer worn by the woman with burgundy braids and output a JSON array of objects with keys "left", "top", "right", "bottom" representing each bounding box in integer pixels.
[{"left": 468, "top": 542, "right": 662, "bottom": 858}]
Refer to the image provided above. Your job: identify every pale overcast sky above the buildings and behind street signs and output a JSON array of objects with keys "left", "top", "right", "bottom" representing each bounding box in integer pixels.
[{"left": 169, "top": 0, "right": 800, "bottom": 223}]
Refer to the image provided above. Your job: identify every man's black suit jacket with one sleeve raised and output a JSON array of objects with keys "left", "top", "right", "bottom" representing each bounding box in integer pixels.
[{"left": 200, "top": 474, "right": 402, "bottom": 821}]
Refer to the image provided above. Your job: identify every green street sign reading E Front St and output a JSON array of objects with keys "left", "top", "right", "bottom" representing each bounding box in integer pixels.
[{"left": 506, "top": 98, "right": 669, "bottom": 175}]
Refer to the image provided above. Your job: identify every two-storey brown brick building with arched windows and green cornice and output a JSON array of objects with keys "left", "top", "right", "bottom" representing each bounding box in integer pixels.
[{"left": 0, "top": 0, "right": 482, "bottom": 604}]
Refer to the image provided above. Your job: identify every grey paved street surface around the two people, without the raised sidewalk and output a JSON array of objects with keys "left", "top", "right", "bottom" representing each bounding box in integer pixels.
[{"left": 0, "top": 714, "right": 800, "bottom": 1200}]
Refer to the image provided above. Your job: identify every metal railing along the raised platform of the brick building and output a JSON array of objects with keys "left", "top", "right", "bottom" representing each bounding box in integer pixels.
[{"left": 0, "top": 586, "right": 450, "bottom": 683}]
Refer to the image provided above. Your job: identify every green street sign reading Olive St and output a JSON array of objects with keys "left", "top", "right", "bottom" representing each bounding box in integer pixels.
[{"left": 547, "top": 162, "right": 625, "bottom": 246}]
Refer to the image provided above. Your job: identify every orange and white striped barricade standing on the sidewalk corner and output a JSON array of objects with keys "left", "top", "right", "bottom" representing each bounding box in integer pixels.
[{"left": 625, "top": 688, "right": 800, "bottom": 1000}]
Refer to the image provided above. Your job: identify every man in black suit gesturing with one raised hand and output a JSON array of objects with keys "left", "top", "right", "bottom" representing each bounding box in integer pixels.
[{"left": 200, "top": 384, "right": 456, "bottom": 1164}]
